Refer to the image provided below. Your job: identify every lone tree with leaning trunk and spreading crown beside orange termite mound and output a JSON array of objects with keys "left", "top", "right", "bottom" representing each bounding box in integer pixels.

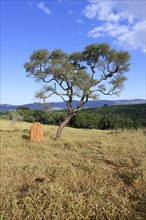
[{"left": 24, "top": 43, "right": 130, "bottom": 140}]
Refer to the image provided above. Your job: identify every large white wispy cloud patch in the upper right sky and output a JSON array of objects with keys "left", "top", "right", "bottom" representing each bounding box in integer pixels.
[{"left": 83, "top": 0, "right": 146, "bottom": 51}]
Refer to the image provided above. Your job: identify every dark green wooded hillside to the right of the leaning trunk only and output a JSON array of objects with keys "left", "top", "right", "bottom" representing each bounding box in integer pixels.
[{"left": 70, "top": 104, "right": 146, "bottom": 130}]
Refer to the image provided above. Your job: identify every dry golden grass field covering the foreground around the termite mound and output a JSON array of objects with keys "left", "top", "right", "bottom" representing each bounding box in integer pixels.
[{"left": 1, "top": 120, "right": 146, "bottom": 220}]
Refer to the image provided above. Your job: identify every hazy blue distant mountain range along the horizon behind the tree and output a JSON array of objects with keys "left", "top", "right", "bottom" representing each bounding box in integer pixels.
[{"left": 0, "top": 99, "right": 146, "bottom": 111}]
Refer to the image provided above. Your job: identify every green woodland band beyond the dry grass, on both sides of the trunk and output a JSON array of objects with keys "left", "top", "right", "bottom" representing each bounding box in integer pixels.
[{"left": 1, "top": 104, "right": 146, "bottom": 130}]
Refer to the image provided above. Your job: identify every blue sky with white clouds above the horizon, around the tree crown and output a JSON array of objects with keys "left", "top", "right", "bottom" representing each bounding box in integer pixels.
[{"left": 1, "top": 0, "right": 146, "bottom": 105}]
